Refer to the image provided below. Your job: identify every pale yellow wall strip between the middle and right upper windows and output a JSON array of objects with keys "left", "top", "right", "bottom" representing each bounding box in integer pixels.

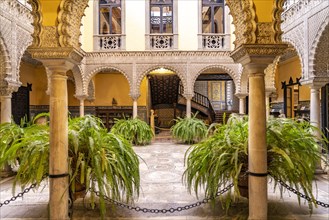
[{"left": 174, "top": 0, "right": 199, "bottom": 50}]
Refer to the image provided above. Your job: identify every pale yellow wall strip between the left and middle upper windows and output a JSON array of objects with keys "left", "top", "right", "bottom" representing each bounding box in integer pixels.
[{"left": 126, "top": 0, "right": 145, "bottom": 51}]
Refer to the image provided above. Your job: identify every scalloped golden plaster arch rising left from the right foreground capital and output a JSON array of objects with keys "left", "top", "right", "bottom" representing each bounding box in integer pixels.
[{"left": 226, "top": 0, "right": 256, "bottom": 47}]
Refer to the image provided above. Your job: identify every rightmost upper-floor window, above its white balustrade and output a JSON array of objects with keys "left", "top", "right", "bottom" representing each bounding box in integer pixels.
[{"left": 202, "top": 0, "right": 224, "bottom": 34}]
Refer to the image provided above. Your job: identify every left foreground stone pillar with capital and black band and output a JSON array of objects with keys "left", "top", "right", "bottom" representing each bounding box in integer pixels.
[{"left": 44, "top": 60, "right": 71, "bottom": 219}]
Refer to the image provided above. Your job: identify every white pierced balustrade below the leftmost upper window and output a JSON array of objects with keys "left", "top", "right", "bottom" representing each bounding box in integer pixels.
[{"left": 94, "top": 34, "right": 122, "bottom": 50}]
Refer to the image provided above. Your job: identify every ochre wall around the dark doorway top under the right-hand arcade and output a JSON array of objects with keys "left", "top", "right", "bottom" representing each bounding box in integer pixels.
[{"left": 275, "top": 57, "right": 310, "bottom": 102}]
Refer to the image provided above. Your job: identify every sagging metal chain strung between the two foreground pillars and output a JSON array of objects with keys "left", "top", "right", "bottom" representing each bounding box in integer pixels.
[{"left": 90, "top": 183, "right": 234, "bottom": 214}]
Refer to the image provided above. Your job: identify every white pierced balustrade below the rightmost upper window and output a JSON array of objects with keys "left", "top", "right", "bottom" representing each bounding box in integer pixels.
[{"left": 202, "top": 34, "right": 230, "bottom": 49}]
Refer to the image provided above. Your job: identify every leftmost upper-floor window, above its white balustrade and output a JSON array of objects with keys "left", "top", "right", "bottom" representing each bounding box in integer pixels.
[{"left": 99, "top": 0, "right": 122, "bottom": 34}]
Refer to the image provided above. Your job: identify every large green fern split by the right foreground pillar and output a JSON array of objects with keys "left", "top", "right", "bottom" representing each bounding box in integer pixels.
[{"left": 184, "top": 115, "right": 324, "bottom": 211}]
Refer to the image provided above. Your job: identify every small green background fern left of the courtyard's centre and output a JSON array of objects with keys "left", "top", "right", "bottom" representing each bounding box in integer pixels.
[{"left": 111, "top": 118, "right": 154, "bottom": 145}]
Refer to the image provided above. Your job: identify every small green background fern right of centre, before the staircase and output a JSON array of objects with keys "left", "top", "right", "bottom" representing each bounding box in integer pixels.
[{"left": 170, "top": 114, "right": 207, "bottom": 144}]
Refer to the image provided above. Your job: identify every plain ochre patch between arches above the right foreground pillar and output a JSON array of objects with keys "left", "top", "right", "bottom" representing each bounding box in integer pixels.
[{"left": 254, "top": 0, "right": 276, "bottom": 22}]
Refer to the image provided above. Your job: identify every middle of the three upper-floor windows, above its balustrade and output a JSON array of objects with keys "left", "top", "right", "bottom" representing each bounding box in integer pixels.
[{"left": 150, "top": 0, "right": 173, "bottom": 34}]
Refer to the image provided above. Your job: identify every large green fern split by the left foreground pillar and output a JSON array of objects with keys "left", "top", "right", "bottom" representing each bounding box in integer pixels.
[{"left": 0, "top": 115, "right": 140, "bottom": 217}]
